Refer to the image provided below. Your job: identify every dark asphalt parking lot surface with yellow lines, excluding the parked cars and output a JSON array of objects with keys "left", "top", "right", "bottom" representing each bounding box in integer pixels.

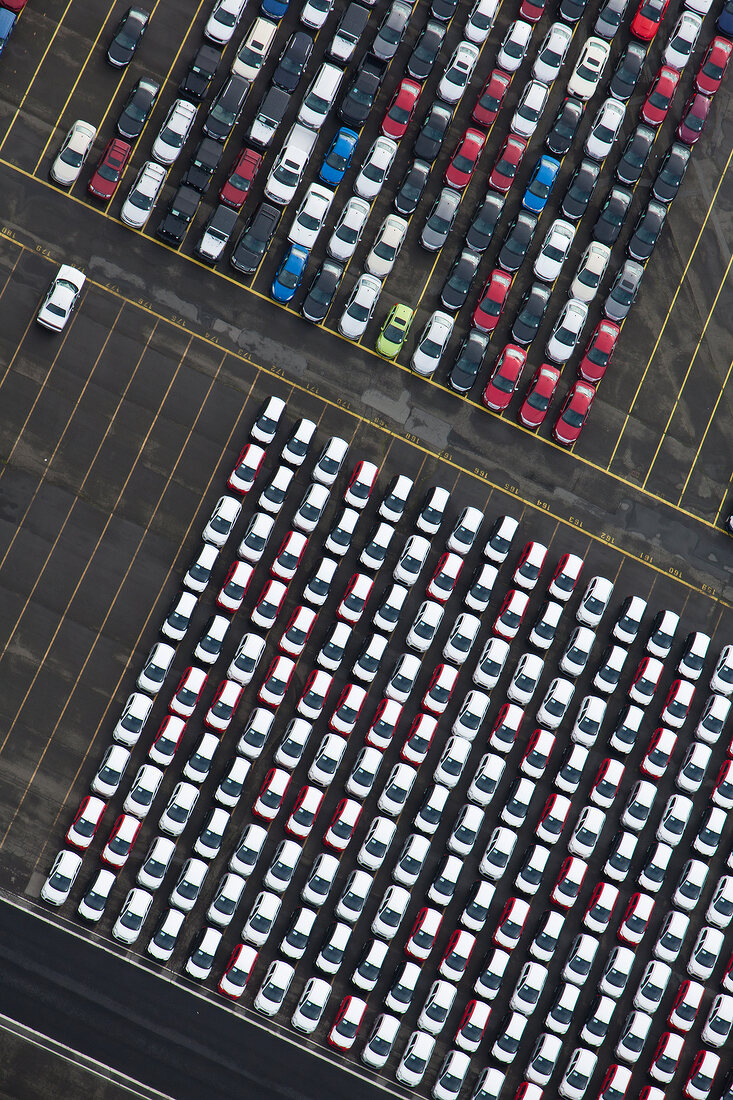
[{"left": 0, "top": 2, "right": 732, "bottom": 1100}]
